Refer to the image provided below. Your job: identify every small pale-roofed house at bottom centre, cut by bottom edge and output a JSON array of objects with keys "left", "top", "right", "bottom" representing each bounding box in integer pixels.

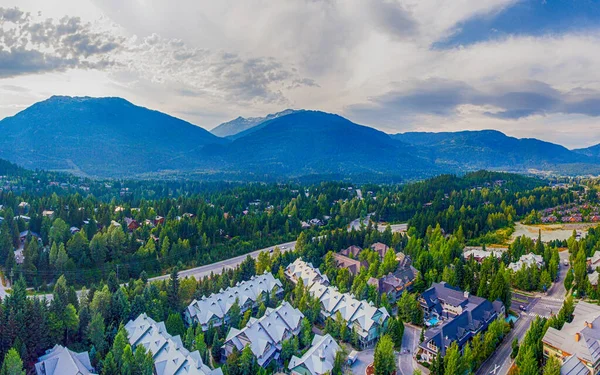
[{"left": 288, "top": 334, "right": 340, "bottom": 375}]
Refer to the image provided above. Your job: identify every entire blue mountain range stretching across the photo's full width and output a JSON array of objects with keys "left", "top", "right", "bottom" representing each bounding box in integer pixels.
[{"left": 0, "top": 96, "right": 600, "bottom": 182}]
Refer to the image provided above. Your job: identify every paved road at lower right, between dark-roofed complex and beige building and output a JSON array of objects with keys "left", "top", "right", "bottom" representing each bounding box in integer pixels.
[{"left": 476, "top": 251, "right": 570, "bottom": 375}]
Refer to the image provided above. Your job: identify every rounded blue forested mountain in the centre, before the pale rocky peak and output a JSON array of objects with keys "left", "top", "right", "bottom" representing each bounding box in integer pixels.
[{"left": 214, "top": 111, "right": 438, "bottom": 178}]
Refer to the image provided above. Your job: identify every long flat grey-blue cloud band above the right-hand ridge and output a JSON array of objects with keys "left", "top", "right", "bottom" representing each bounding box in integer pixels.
[{"left": 347, "top": 79, "right": 600, "bottom": 120}]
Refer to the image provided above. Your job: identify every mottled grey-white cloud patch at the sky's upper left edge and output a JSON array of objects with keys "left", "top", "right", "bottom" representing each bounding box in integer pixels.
[{"left": 0, "top": 8, "right": 124, "bottom": 78}]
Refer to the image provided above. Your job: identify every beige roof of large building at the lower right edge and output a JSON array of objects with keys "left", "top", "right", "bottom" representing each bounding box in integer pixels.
[{"left": 542, "top": 302, "right": 600, "bottom": 363}]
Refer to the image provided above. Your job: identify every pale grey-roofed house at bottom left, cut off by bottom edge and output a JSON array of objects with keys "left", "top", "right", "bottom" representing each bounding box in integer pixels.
[{"left": 35, "top": 345, "right": 95, "bottom": 375}]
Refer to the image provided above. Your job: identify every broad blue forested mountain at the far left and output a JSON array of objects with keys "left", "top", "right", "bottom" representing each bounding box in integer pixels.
[{"left": 0, "top": 96, "right": 226, "bottom": 177}]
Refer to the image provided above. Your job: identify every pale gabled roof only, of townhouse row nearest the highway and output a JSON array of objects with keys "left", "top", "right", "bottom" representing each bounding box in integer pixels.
[{"left": 186, "top": 272, "right": 283, "bottom": 325}]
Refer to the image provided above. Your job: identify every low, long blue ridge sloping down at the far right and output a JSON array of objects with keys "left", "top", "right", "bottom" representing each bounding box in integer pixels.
[{"left": 392, "top": 130, "right": 598, "bottom": 171}]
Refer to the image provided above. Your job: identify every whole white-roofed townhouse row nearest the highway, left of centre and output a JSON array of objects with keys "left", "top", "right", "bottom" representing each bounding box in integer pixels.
[{"left": 184, "top": 272, "right": 283, "bottom": 331}]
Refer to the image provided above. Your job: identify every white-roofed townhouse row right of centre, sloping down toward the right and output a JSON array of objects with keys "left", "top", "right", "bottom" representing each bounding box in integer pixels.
[{"left": 310, "top": 283, "right": 390, "bottom": 348}]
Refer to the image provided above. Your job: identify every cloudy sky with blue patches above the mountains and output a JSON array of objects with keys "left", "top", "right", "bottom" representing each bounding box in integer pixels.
[{"left": 0, "top": 0, "right": 600, "bottom": 148}]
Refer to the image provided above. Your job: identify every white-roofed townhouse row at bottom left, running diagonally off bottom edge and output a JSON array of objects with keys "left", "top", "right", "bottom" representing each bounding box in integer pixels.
[{"left": 125, "top": 314, "right": 223, "bottom": 375}]
